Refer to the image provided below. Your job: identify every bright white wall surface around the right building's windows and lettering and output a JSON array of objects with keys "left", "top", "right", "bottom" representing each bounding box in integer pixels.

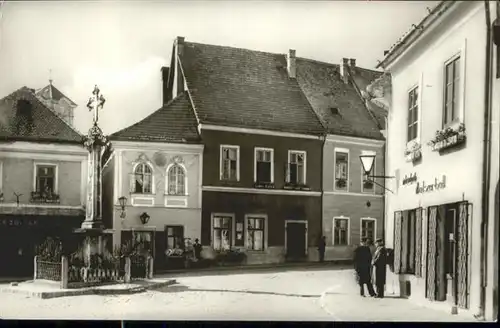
[{"left": 386, "top": 2, "right": 485, "bottom": 311}]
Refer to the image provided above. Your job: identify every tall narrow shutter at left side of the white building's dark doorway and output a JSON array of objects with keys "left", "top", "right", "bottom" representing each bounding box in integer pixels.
[{"left": 426, "top": 206, "right": 437, "bottom": 301}]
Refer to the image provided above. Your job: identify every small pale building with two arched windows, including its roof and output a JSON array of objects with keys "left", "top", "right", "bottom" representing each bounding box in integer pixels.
[{"left": 103, "top": 88, "right": 203, "bottom": 269}]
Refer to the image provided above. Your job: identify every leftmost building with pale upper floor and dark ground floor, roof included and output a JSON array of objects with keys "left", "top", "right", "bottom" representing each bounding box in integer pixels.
[{"left": 0, "top": 87, "right": 88, "bottom": 276}]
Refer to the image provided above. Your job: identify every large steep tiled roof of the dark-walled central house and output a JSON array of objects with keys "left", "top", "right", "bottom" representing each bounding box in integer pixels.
[{"left": 181, "top": 42, "right": 324, "bottom": 135}]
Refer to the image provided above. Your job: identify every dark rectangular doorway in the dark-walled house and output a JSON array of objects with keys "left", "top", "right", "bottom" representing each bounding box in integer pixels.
[{"left": 285, "top": 220, "right": 307, "bottom": 261}]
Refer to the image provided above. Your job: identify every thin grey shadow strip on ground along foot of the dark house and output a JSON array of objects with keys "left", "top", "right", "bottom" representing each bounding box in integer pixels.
[{"left": 155, "top": 263, "right": 352, "bottom": 277}]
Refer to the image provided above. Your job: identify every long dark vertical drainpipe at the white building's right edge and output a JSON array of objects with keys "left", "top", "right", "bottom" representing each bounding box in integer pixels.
[{"left": 478, "top": 0, "right": 493, "bottom": 319}]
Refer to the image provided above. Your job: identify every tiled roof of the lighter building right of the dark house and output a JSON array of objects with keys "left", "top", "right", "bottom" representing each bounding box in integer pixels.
[{"left": 297, "top": 58, "right": 383, "bottom": 139}]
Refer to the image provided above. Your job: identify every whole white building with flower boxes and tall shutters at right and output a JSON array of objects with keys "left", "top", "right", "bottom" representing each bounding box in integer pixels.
[{"left": 380, "top": 1, "right": 498, "bottom": 319}]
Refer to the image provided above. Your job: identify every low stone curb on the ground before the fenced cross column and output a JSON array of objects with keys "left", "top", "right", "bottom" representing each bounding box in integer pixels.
[{"left": 0, "top": 279, "right": 177, "bottom": 299}]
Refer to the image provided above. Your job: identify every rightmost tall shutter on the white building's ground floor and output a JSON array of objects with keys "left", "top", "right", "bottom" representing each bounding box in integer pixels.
[{"left": 457, "top": 202, "right": 472, "bottom": 309}]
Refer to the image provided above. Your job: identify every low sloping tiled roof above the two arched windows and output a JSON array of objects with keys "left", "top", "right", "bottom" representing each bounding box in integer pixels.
[{"left": 110, "top": 93, "right": 200, "bottom": 143}]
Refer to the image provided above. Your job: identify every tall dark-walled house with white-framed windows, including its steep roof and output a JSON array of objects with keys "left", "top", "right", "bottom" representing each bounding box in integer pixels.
[{"left": 164, "top": 37, "right": 324, "bottom": 264}]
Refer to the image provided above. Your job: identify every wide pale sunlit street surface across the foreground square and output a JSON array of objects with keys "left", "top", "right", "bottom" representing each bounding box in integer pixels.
[{"left": 0, "top": 268, "right": 476, "bottom": 321}]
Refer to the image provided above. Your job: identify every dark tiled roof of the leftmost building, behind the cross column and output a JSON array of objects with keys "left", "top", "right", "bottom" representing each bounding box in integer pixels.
[{"left": 0, "top": 87, "right": 82, "bottom": 143}]
